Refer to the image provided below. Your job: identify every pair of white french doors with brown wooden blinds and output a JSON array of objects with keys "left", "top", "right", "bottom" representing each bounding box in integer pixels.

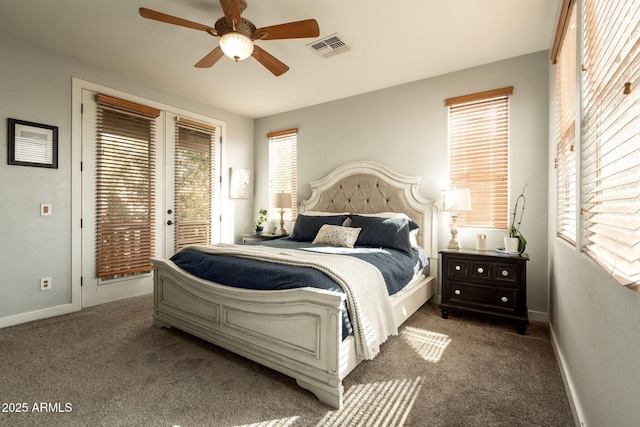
[{"left": 81, "top": 90, "right": 220, "bottom": 307}]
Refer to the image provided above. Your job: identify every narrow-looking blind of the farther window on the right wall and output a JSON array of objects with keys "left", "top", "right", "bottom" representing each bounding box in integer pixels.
[{"left": 555, "top": 3, "right": 577, "bottom": 245}]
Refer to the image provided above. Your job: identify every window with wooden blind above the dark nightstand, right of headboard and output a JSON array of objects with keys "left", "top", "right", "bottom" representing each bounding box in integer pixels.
[{"left": 446, "top": 87, "right": 513, "bottom": 229}]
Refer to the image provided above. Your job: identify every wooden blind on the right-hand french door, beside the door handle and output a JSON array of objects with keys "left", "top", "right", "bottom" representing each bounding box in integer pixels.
[{"left": 174, "top": 118, "right": 217, "bottom": 252}]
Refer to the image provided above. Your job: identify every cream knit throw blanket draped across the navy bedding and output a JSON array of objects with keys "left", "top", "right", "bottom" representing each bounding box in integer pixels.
[{"left": 185, "top": 243, "right": 398, "bottom": 359}]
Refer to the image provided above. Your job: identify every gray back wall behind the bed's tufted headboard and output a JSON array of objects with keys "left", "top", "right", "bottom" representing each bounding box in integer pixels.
[{"left": 254, "top": 51, "right": 548, "bottom": 320}]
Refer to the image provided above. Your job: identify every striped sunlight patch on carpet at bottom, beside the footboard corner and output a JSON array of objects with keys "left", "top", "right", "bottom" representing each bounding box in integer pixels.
[{"left": 318, "top": 377, "right": 424, "bottom": 427}]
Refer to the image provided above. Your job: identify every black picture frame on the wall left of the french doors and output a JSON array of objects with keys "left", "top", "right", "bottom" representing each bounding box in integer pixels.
[{"left": 7, "top": 118, "right": 58, "bottom": 169}]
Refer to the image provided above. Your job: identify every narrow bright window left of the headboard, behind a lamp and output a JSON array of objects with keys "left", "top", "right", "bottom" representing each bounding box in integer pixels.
[{"left": 267, "top": 129, "right": 298, "bottom": 221}]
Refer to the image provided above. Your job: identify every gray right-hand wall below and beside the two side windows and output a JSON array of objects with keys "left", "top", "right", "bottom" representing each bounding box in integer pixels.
[{"left": 548, "top": 41, "right": 640, "bottom": 427}]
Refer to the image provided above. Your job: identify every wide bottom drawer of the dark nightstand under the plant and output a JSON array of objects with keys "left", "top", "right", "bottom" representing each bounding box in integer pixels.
[{"left": 444, "top": 282, "right": 518, "bottom": 312}]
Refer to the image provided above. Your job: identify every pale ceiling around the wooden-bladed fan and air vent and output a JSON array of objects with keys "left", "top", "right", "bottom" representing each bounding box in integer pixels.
[{"left": 0, "top": 0, "right": 561, "bottom": 118}]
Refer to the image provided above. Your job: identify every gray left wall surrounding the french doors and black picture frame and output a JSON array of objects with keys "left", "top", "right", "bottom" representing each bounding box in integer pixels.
[{"left": 0, "top": 36, "right": 254, "bottom": 325}]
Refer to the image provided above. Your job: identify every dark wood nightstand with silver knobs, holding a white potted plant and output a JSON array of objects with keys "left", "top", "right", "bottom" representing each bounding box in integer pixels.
[{"left": 440, "top": 249, "right": 529, "bottom": 335}]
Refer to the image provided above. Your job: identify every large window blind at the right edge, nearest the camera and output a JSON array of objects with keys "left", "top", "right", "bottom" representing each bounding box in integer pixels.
[{"left": 582, "top": 0, "right": 640, "bottom": 286}]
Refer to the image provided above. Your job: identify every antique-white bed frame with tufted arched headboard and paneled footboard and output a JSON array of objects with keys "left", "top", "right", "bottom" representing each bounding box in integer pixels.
[{"left": 152, "top": 161, "right": 438, "bottom": 408}]
